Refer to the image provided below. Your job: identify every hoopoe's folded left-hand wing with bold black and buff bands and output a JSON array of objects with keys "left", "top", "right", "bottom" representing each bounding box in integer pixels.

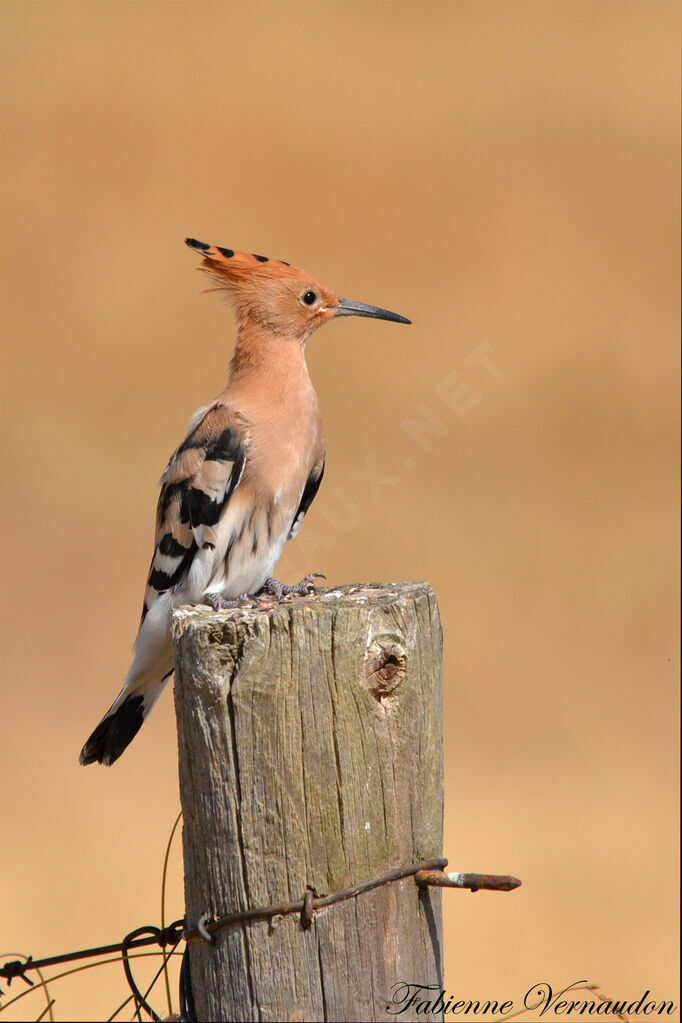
[{"left": 142, "top": 402, "right": 248, "bottom": 621}]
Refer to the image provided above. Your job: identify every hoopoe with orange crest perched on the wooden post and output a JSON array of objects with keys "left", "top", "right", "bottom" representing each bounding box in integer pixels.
[{"left": 80, "top": 238, "right": 410, "bottom": 764}]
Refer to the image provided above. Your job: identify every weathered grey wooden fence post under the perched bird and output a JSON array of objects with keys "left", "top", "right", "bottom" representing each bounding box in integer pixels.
[{"left": 174, "top": 582, "right": 443, "bottom": 1021}]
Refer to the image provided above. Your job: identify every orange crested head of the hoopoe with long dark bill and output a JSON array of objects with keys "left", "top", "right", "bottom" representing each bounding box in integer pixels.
[{"left": 185, "top": 238, "right": 410, "bottom": 344}]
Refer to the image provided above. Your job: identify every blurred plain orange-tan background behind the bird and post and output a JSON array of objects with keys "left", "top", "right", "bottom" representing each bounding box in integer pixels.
[{"left": 0, "top": 0, "right": 680, "bottom": 1020}]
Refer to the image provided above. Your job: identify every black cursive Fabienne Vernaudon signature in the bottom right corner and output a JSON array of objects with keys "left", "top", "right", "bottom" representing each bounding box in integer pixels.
[{"left": 385, "top": 980, "right": 678, "bottom": 1020}]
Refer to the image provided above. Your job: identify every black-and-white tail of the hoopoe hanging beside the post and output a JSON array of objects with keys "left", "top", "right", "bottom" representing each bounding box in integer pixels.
[{"left": 80, "top": 649, "right": 173, "bottom": 766}]
